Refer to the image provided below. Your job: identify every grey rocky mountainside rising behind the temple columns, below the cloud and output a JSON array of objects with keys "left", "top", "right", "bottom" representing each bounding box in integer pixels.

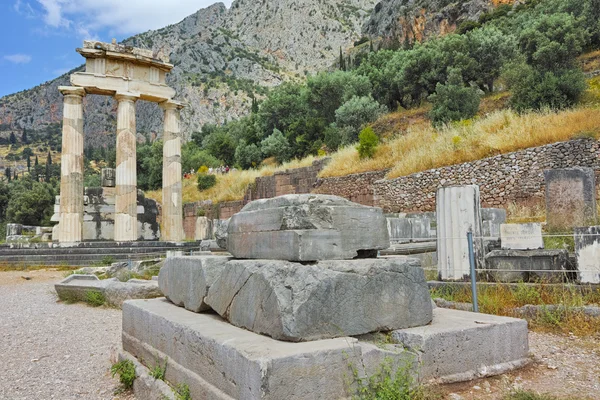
[{"left": 0, "top": 0, "right": 377, "bottom": 146}]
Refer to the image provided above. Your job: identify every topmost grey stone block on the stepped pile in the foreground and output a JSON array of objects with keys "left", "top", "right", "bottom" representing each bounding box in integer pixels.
[{"left": 227, "top": 194, "right": 389, "bottom": 261}]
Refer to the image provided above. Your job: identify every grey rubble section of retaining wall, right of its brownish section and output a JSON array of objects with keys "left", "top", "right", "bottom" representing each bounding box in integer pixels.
[{"left": 373, "top": 139, "right": 600, "bottom": 212}]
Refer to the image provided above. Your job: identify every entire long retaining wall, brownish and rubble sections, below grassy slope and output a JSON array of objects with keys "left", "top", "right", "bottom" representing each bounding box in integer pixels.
[{"left": 184, "top": 139, "right": 600, "bottom": 239}]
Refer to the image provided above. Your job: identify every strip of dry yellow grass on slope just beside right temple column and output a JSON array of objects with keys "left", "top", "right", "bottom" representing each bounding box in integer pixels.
[{"left": 146, "top": 156, "right": 316, "bottom": 204}]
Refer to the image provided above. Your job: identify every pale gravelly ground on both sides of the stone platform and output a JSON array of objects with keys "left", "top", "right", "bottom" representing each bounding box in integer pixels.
[{"left": 0, "top": 271, "right": 600, "bottom": 400}]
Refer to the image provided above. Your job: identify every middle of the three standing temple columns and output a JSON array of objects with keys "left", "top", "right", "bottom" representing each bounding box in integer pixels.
[{"left": 115, "top": 93, "right": 138, "bottom": 242}]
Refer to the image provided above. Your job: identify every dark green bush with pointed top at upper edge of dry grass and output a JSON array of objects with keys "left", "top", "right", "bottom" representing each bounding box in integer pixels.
[{"left": 429, "top": 69, "right": 481, "bottom": 126}]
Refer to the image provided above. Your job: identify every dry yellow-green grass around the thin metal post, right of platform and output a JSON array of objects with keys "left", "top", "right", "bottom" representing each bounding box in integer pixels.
[{"left": 432, "top": 284, "right": 600, "bottom": 336}]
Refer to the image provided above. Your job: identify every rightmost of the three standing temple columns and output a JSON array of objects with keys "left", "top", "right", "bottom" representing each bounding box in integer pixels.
[{"left": 161, "top": 101, "right": 185, "bottom": 242}]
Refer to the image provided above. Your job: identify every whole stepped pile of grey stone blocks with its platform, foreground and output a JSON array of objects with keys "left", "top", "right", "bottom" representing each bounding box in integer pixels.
[{"left": 120, "top": 195, "right": 528, "bottom": 399}]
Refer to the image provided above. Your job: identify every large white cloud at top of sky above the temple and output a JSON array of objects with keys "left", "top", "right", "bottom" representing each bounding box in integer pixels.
[{"left": 34, "top": 0, "right": 232, "bottom": 38}]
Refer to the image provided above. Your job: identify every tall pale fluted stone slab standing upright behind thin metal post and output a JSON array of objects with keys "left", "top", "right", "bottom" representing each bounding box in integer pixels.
[{"left": 436, "top": 185, "right": 484, "bottom": 280}]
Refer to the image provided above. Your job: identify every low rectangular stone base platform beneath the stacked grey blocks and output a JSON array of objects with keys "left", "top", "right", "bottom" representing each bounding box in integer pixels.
[{"left": 122, "top": 299, "right": 528, "bottom": 400}]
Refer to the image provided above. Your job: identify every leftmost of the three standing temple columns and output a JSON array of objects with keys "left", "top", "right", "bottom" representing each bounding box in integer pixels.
[{"left": 58, "top": 86, "right": 85, "bottom": 243}]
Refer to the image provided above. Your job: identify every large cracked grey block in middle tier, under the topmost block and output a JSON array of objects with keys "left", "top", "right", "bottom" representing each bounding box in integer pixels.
[{"left": 205, "top": 258, "right": 431, "bottom": 341}]
